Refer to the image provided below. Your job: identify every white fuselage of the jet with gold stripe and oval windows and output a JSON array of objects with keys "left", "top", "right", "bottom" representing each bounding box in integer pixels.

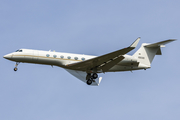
[{"left": 4, "top": 49, "right": 149, "bottom": 72}]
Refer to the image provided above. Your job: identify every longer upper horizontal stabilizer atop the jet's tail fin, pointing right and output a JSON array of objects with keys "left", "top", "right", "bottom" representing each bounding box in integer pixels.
[{"left": 145, "top": 39, "right": 176, "bottom": 47}]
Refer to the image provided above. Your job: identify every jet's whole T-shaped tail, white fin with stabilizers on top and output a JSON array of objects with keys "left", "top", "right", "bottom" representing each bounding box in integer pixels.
[{"left": 133, "top": 39, "right": 175, "bottom": 67}]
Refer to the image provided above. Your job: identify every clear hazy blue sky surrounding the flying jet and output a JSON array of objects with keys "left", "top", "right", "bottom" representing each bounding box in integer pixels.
[{"left": 0, "top": 0, "right": 180, "bottom": 120}]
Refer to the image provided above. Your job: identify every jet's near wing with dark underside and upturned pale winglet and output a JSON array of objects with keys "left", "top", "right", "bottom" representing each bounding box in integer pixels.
[{"left": 66, "top": 38, "right": 140, "bottom": 72}]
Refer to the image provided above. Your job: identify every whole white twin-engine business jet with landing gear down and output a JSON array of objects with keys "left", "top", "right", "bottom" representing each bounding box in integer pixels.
[{"left": 3, "top": 37, "right": 176, "bottom": 86}]
